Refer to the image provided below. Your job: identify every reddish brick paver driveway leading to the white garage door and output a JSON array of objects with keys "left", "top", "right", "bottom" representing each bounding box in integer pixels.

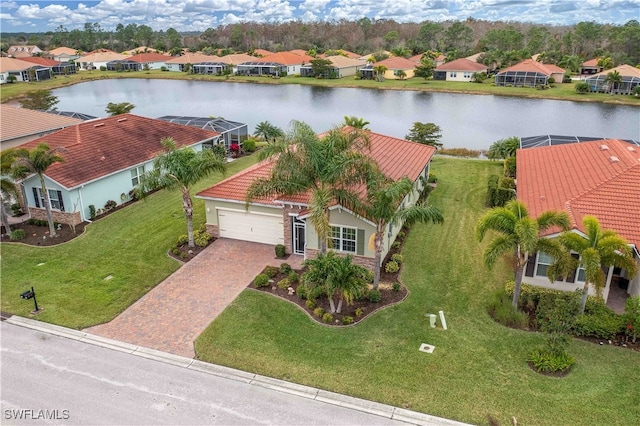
[{"left": 86, "top": 238, "right": 302, "bottom": 358}]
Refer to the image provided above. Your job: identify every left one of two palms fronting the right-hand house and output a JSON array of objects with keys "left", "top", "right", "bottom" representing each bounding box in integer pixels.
[{"left": 476, "top": 200, "right": 570, "bottom": 309}]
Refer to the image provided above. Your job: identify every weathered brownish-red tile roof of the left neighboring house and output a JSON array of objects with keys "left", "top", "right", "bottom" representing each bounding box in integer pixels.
[{"left": 22, "top": 114, "right": 220, "bottom": 188}]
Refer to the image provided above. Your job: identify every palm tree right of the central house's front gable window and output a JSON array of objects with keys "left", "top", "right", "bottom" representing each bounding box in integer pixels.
[{"left": 339, "top": 173, "right": 444, "bottom": 289}]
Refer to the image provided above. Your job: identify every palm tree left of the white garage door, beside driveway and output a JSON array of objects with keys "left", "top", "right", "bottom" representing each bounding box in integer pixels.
[{"left": 136, "top": 138, "right": 227, "bottom": 247}]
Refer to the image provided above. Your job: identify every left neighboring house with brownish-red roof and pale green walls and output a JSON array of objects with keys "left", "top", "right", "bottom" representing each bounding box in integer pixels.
[{"left": 20, "top": 114, "right": 220, "bottom": 224}]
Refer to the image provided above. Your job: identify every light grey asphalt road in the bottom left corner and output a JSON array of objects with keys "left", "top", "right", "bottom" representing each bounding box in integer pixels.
[{"left": 0, "top": 322, "right": 406, "bottom": 425}]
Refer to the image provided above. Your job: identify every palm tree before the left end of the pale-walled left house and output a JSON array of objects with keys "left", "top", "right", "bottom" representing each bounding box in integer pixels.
[{"left": 13, "top": 143, "right": 64, "bottom": 237}]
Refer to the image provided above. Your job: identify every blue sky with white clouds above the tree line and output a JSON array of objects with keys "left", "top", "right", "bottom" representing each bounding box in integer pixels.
[{"left": 0, "top": 0, "right": 640, "bottom": 32}]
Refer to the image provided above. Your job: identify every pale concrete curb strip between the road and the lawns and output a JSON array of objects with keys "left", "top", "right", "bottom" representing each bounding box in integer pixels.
[{"left": 3, "top": 316, "right": 470, "bottom": 426}]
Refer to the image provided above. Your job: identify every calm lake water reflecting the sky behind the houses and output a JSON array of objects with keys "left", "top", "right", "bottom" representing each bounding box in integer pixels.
[{"left": 53, "top": 79, "right": 640, "bottom": 149}]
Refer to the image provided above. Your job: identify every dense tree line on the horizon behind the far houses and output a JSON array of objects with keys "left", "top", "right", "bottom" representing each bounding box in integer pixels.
[{"left": 1, "top": 18, "right": 640, "bottom": 66}]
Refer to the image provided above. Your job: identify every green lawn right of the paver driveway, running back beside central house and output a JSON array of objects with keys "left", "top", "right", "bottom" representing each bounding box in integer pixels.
[{"left": 196, "top": 157, "right": 640, "bottom": 425}]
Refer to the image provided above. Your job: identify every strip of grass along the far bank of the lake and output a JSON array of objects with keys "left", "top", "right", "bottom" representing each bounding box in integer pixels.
[{"left": 0, "top": 70, "right": 640, "bottom": 106}]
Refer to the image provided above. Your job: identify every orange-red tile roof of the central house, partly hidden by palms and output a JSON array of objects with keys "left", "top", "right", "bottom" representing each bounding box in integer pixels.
[{"left": 198, "top": 132, "right": 436, "bottom": 209}]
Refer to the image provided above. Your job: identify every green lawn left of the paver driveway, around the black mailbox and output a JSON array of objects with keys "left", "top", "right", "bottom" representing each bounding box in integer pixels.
[{"left": 1, "top": 156, "right": 256, "bottom": 329}]
